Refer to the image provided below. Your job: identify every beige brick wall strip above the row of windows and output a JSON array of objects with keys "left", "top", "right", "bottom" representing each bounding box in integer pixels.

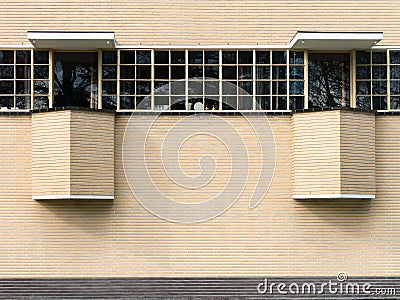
[{"left": 0, "top": 0, "right": 400, "bottom": 46}]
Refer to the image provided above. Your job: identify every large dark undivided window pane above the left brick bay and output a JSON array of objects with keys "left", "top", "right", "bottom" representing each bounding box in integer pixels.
[{"left": 54, "top": 52, "right": 97, "bottom": 107}]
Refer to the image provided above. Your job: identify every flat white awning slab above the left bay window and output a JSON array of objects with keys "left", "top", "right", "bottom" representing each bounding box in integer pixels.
[{"left": 27, "top": 31, "right": 115, "bottom": 50}]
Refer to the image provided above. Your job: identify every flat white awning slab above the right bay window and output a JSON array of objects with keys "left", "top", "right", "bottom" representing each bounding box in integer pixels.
[{"left": 290, "top": 31, "right": 383, "bottom": 50}]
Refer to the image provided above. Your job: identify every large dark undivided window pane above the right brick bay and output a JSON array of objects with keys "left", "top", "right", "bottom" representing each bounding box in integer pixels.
[{"left": 308, "top": 53, "right": 350, "bottom": 108}]
